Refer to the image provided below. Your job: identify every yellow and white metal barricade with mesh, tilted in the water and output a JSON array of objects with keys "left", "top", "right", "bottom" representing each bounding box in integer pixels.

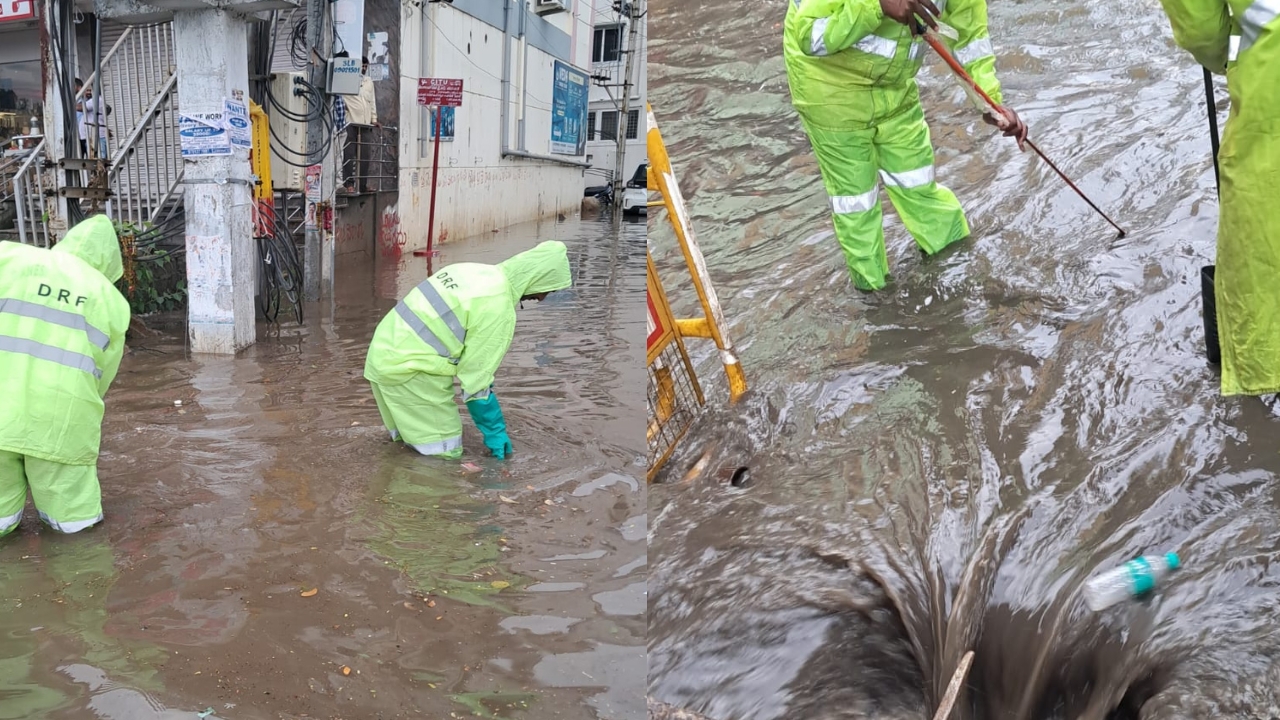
[{"left": 645, "top": 106, "right": 746, "bottom": 480}]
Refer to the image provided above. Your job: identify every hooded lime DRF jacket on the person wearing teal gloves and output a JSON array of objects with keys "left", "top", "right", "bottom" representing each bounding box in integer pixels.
[{"left": 365, "top": 241, "right": 572, "bottom": 400}]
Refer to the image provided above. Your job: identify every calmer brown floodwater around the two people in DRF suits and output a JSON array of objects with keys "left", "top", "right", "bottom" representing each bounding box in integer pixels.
[{"left": 0, "top": 212, "right": 646, "bottom": 720}]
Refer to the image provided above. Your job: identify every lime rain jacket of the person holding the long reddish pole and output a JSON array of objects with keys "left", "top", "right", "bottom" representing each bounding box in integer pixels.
[{"left": 782, "top": 0, "right": 1004, "bottom": 129}]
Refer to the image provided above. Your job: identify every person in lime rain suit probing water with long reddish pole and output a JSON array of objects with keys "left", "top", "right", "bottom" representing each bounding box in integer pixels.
[{"left": 783, "top": 0, "right": 1027, "bottom": 291}]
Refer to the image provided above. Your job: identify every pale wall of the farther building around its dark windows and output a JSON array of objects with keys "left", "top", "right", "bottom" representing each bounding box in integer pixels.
[{"left": 585, "top": 0, "right": 649, "bottom": 186}]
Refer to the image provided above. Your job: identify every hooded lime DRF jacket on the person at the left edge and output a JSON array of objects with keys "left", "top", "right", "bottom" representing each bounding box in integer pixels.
[{"left": 0, "top": 215, "right": 129, "bottom": 465}]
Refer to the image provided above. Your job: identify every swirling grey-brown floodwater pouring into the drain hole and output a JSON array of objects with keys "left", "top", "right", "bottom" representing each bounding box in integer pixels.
[{"left": 648, "top": 0, "right": 1280, "bottom": 720}]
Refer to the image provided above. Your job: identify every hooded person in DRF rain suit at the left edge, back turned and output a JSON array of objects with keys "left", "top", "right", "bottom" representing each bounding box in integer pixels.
[{"left": 0, "top": 215, "right": 129, "bottom": 536}]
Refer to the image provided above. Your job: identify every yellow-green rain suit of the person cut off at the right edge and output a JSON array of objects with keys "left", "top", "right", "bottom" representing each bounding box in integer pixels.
[{"left": 1161, "top": 0, "right": 1280, "bottom": 396}]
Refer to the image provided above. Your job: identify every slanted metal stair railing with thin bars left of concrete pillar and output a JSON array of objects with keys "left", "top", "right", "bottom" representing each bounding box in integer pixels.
[{"left": 108, "top": 74, "right": 183, "bottom": 225}]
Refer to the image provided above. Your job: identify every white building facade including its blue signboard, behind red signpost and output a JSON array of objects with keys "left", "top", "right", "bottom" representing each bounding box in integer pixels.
[{"left": 384, "top": 0, "right": 593, "bottom": 250}]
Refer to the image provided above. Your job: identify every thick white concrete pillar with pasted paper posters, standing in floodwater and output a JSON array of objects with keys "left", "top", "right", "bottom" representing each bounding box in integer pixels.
[{"left": 173, "top": 9, "right": 257, "bottom": 354}]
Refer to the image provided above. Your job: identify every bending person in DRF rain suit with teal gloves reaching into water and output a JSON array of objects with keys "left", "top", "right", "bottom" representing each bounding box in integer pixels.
[{"left": 365, "top": 241, "right": 571, "bottom": 459}]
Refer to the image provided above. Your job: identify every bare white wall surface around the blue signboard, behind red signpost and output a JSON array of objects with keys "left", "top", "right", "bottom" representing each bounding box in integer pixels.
[{"left": 394, "top": 0, "right": 591, "bottom": 251}]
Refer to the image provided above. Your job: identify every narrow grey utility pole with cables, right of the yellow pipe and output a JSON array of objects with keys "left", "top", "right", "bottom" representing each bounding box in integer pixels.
[{"left": 302, "top": 0, "right": 327, "bottom": 302}]
